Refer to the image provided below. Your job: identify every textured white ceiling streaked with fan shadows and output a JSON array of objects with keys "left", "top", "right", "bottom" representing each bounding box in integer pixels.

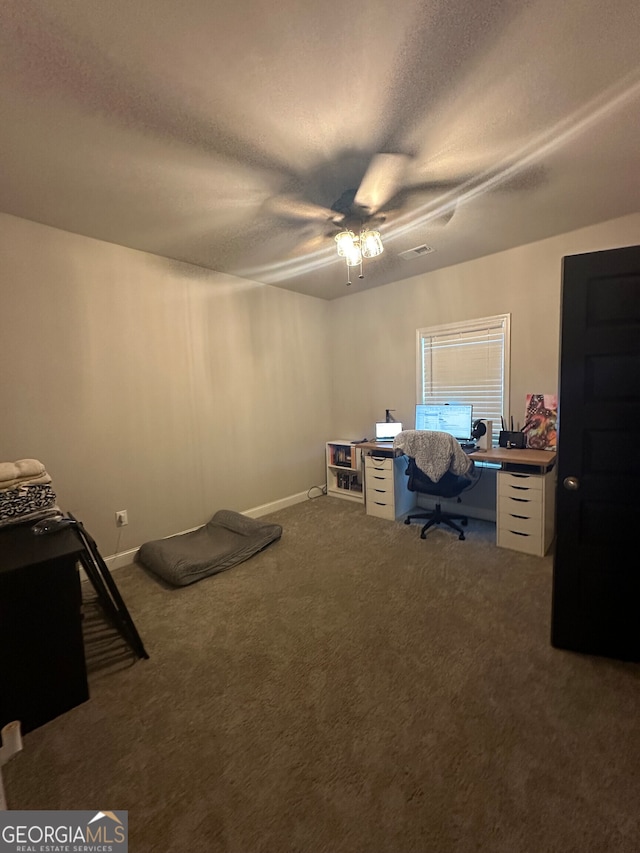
[{"left": 0, "top": 0, "right": 640, "bottom": 299}]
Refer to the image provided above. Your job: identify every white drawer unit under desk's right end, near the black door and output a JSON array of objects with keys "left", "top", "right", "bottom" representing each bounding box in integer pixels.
[{"left": 496, "top": 471, "right": 556, "bottom": 557}]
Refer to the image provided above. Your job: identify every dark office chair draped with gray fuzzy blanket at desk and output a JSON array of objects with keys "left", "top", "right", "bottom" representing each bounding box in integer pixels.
[{"left": 394, "top": 430, "right": 475, "bottom": 539}]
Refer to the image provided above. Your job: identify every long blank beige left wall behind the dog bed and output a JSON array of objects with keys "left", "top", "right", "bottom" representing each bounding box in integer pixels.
[{"left": 0, "top": 214, "right": 331, "bottom": 556}]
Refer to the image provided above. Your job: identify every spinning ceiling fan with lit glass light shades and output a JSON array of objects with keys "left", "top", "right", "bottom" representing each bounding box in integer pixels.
[{"left": 267, "top": 153, "right": 453, "bottom": 284}]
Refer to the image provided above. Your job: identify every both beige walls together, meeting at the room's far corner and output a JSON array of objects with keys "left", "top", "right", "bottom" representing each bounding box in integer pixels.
[{"left": 0, "top": 214, "right": 640, "bottom": 556}]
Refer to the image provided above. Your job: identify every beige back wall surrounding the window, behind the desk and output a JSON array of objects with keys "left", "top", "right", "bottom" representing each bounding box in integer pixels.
[{"left": 330, "top": 214, "right": 640, "bottom": 438}]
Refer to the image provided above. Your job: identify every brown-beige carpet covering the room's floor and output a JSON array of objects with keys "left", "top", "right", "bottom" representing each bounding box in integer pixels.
[{"left": 4, "top": 497, "right": 640, "bottom": 853}]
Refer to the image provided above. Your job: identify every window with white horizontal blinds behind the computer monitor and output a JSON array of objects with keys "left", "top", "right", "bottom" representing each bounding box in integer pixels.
[{"left": 417, "top": 314, "right": 511, "bottom": 445}]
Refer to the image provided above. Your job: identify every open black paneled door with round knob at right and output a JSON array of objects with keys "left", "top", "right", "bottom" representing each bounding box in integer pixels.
[{"left": 551, "top": 246, "right": 640, "bottom": 660}]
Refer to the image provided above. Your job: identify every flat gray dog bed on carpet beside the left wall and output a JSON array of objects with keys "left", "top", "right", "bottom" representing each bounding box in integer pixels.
[{"left": 138, "top": 509, "right": 282, "bottom": 586}]
